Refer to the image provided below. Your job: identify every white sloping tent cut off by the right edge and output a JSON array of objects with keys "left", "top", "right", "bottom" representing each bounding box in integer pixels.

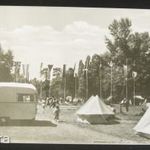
[{"left": 134, "top": 107, "right": 150, "bottom": 138}]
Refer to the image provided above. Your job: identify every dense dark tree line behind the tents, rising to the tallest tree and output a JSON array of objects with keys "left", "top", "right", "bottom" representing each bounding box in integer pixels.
[{"left": 51, "top": 18, "right": 150, "bottom": 102}]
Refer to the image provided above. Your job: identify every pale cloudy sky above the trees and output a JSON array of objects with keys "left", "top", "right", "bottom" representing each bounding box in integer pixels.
[{"left": 0, "top": 6, "right": 150, "bottom": 79}]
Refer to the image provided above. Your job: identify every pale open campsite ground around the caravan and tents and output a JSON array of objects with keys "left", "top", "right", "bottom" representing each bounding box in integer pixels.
[{"left": 0, "top": 95, "right": 149, "bottom": 144}]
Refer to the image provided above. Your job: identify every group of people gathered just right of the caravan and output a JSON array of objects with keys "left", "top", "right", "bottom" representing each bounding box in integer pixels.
[{"left": 42, "top": 97, "right": 60, "bottom": 121}]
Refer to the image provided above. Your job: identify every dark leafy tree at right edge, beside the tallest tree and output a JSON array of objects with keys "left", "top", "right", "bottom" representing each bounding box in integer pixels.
[{"left": 131, "top": 32, "right": 150, "bottom": 97}]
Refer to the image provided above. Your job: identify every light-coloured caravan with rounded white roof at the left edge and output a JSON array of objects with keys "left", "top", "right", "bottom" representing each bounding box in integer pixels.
[{"left": 0, "top": 82, "right": 37, "bottom": 120}]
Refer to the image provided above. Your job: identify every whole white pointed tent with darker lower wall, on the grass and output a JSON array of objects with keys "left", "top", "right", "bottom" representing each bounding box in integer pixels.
[{"left": 76, "top": 96, "right": 114, "bottom": 124}]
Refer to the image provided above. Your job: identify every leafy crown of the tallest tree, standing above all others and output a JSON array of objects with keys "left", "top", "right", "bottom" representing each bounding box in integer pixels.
[{"left": 106, "top": 18, "right": 131, "bottom": 65}]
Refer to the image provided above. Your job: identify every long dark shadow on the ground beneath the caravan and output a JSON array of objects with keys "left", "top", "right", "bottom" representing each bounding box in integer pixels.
[{"left": 0, "top": 120, "right": 57, "bottom": 127}]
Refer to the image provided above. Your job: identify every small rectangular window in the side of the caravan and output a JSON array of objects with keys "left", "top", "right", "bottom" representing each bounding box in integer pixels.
[{"left": 18, "top": 94, "right": 34, "bottom": 102}]
